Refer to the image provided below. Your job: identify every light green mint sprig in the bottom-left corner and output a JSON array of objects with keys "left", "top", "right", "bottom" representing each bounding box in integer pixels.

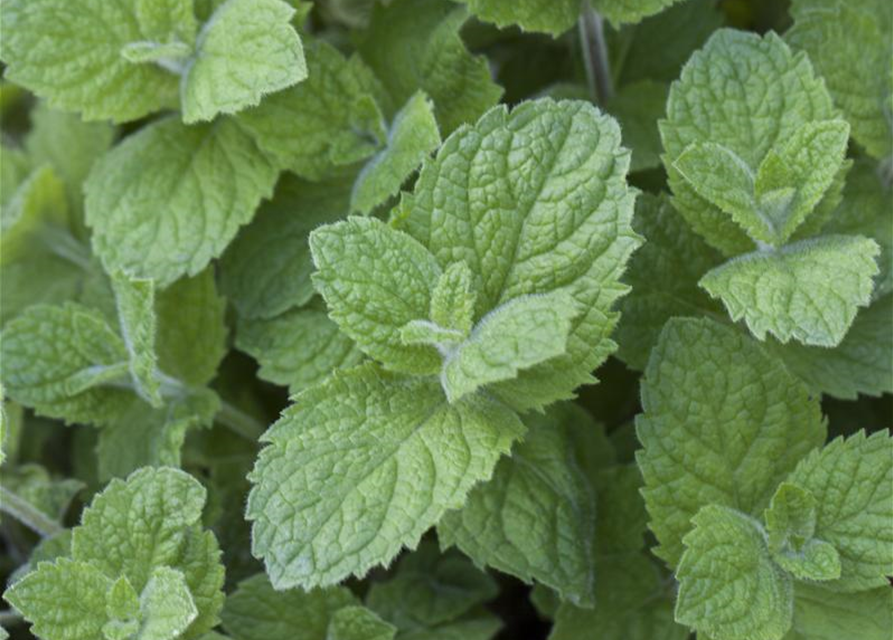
[{"left": 4, "top": 468, "right": 223, "bottom": 640}]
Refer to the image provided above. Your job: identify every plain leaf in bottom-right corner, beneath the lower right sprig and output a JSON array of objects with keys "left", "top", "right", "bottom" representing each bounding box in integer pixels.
[{"left": 785, "top": 582, "right": 893, "bottom": 640}]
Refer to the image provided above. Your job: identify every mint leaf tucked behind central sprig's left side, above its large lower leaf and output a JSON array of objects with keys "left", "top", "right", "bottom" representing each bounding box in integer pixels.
[{"left": 236, "top": 304, "right": 363, "bottom": 394}]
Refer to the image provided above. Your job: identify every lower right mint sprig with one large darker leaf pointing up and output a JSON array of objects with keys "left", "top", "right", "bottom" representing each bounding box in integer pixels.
[{"left": 637, "top": 320, "right": 893, "bottom": 639}]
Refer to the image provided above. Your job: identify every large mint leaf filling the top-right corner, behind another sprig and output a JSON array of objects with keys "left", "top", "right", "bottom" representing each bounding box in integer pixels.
[{"left": 785, "top": 0, "right": 893, "bottom": 159}]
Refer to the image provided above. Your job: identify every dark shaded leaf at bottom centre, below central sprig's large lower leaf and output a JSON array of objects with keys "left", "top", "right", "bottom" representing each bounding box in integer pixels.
[{"left": 366, "top": 542, "right": 499, "bottom": 638}]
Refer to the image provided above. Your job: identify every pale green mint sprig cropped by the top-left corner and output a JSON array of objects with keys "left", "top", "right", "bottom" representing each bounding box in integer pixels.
[{"left": 2, "top": 0, "right": 307, "bottom": 123}]
